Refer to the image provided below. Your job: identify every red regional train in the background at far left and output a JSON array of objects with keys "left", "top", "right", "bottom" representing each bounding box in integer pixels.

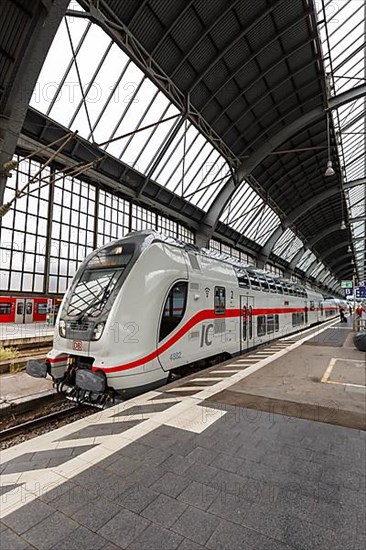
[{"left": 0, "top": 296, "right": 61, "bottom": 324}]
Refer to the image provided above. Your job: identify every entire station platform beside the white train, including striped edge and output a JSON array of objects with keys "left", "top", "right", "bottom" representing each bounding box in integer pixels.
[{"left": 0, "top": 321, "right": 366, "bottom": 550}]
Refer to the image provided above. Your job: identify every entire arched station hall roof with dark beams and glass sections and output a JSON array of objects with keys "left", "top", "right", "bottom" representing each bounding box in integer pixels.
[{"left": 0, "top": 0, "right": 366, "bottom": 294}]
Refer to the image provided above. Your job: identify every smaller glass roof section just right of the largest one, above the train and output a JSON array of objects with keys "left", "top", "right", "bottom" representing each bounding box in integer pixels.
[{"left": 220, "top": 181, "right": 280, "bottom": 246}]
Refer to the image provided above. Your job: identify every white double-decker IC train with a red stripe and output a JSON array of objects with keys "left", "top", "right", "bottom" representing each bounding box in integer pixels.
[{"left": 27, "top": 231, "right": 344, "bottom": 401}]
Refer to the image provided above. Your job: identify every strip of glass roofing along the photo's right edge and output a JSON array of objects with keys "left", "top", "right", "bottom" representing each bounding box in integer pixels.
[{"left": 316, "top": 0, "right": 366, "bottom": 280}]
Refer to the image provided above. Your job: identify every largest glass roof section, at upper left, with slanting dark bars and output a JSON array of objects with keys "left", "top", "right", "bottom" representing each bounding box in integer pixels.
[{"left": 30, "top": 6, "right": 230, "bottom": 210}]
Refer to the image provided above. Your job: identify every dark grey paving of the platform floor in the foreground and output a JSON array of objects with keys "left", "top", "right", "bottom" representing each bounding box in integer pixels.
[{"left": 1, "top": 403, "right": 366, "bottom": 550}]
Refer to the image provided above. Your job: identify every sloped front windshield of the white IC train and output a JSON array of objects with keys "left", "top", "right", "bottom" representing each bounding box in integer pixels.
[{"left": 67, "top": 244, "right": 134, "bottom": 317}]
